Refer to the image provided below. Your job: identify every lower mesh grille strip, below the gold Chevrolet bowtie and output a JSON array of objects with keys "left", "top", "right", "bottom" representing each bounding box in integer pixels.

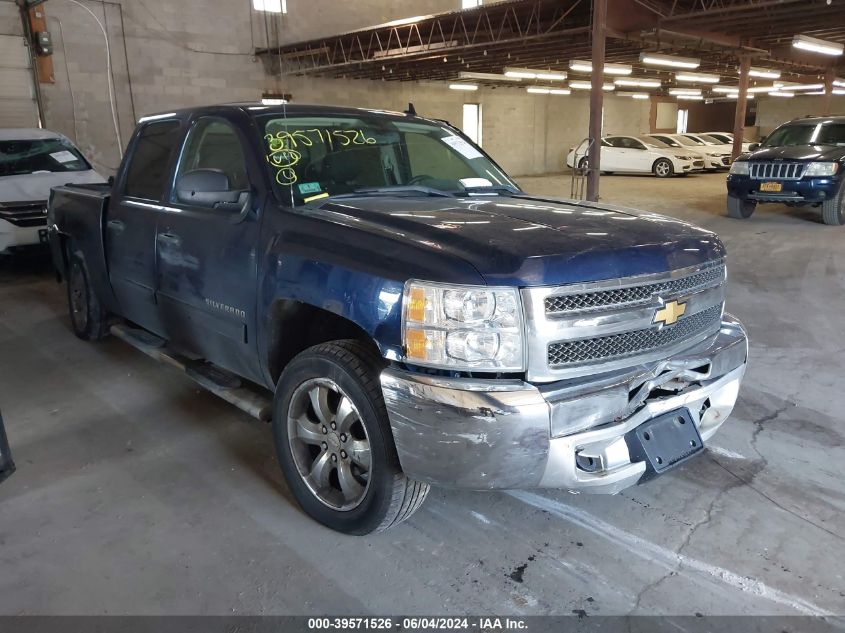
[{"left": 548, "top": 304, "right": 722, "bottom": 368}]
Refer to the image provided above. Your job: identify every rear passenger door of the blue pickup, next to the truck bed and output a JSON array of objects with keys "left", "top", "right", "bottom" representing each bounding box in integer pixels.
[{"left": 105, "top": 120, "right": 183, "bottom": 335}]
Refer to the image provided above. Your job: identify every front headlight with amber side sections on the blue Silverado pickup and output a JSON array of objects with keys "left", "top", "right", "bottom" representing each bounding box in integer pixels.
[{"left": 402, "top": 281, "right": 525, "bottom": 371}]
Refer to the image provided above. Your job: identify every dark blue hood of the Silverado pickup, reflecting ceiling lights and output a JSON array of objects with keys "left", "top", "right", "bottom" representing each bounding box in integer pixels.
[{"left": 314, "top": 195, "right": 725, "bottom": 286}]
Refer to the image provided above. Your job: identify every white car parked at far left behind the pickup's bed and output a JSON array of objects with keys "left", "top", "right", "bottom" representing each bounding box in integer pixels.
[{"left": 0, "top": 129, "right": 105, "bottom": 254}]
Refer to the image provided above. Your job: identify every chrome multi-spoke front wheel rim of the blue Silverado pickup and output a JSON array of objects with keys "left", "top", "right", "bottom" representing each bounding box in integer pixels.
[{"left": 288, "top": 378, "right": 371, "bottom": 511}]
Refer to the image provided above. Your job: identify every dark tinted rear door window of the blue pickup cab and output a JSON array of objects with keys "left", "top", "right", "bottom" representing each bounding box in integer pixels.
[{"left": 123, "top": 121, "right": 181, "bottom": 201}]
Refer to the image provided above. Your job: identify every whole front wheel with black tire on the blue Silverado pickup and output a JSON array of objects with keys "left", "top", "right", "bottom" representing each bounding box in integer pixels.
[{"left": 273, "top": 340, "right": 429, "bottom": 535}]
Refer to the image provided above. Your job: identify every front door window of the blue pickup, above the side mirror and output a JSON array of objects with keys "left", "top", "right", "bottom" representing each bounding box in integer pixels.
[{"left": 176, "top": 118, "right": 249, "bottom": 198}]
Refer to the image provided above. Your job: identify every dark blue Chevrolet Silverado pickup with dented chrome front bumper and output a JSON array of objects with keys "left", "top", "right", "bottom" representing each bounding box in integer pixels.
[{"left": 49, "top": 104, "right": 747, "bottom": 534}]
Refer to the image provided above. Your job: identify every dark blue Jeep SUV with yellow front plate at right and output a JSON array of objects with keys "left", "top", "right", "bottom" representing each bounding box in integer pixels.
[{"left": 728, "top": 116, "right": 845, "bottom": 226}]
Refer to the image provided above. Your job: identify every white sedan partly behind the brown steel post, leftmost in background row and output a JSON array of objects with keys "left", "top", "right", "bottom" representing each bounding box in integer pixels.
[{"left": 566, "top": 136, "right": 694, "bottom": 178}]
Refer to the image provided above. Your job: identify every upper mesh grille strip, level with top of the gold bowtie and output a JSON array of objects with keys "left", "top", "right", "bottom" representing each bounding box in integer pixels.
[{"left": 545, "top": 265, "right": 725, "bottom": 316}]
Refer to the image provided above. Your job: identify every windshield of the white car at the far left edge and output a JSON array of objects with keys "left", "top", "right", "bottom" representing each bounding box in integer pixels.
[{"left": 0, "top": 138, "right": 91, "bottom": 176}]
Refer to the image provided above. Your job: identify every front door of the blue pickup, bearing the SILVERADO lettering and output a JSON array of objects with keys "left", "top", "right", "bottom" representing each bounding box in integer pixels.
[{"left": 156, "top": 116, "right": 261, "bottom": 380}]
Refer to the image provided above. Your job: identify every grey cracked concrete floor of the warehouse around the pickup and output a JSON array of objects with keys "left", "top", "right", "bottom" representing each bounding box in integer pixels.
[{"left": 0, "top": 175, "right": 845, "bottom": 615}]
